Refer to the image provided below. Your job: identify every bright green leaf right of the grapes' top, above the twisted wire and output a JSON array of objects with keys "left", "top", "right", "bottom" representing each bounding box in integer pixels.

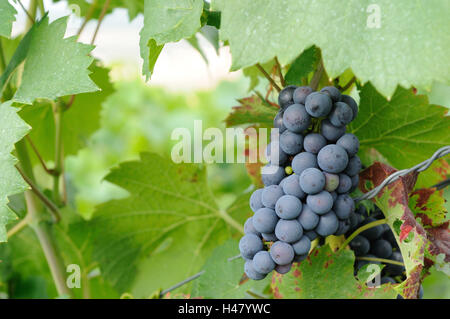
[{"left": 348, "top": 84, "right": 450, "bottom": 171}]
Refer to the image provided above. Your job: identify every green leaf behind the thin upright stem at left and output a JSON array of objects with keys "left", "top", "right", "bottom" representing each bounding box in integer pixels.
[{"left": 20, "top": 63, "right": 114, "bottom": 161}]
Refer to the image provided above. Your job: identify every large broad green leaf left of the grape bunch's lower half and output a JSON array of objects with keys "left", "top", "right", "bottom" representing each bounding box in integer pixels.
[{"left": 91, "top": 153, "right": 243, "bottom": 296}]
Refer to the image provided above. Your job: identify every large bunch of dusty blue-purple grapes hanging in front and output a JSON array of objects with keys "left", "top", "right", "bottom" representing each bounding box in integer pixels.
[{"left": 239, "top": 86, "right": 361, "bottom": 280}]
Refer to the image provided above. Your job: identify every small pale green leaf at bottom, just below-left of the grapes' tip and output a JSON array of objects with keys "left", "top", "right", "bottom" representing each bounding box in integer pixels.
[{"left": 191, "top": 241, "right": 270, "bottom": 299}]
